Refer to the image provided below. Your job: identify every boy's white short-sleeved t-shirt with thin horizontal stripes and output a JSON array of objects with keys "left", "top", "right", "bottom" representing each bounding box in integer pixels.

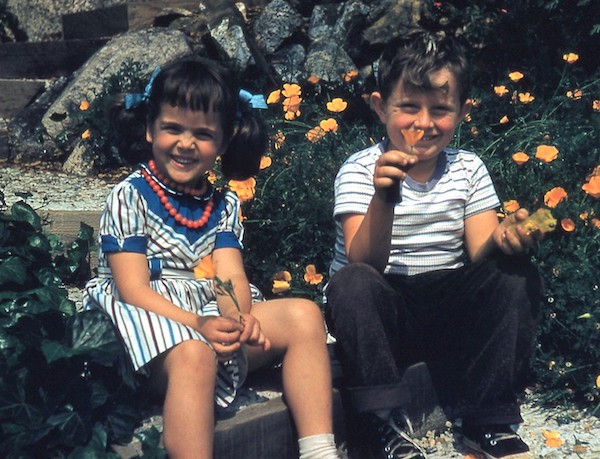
[{"left": 330, "top": 143, "right": 500, "bottom": 275}]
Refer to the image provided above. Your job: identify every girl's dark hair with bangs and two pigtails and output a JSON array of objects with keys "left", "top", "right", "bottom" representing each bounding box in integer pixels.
[{"left": 113, "top": 55, "right": 268, "bottom": 180}]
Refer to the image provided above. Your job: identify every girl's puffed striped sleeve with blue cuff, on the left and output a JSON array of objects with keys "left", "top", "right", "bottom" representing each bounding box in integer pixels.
[{"left": 99, "top": 181, "right": 148, "bottom": 254}]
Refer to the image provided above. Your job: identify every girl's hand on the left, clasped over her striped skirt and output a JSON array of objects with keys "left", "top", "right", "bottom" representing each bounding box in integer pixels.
[{"left": 197, "top": 316, "right": 244, "bottom": 362}]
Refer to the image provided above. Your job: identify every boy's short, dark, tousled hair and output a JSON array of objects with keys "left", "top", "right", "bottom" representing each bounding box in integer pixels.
[{"left": 377, "top": 29, "right": 471, "bottom": 104}]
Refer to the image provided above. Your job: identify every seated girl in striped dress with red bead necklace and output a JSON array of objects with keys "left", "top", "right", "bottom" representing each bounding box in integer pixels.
[{"left": 84, "top": 56, "right": 338, "bottom": 459}]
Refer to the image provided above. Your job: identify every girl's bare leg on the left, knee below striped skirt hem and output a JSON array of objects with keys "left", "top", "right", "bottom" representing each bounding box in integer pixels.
[{"left": 152, "top": 340, "right": 217, "bottom": 459}]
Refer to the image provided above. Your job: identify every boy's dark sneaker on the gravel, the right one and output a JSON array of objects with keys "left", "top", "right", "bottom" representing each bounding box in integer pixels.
[{"left": 461, "top": 425, "right": 533, "bottom": 459}]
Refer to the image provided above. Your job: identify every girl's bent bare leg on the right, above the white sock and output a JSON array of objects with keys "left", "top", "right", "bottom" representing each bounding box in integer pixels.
[{"left": 248, "top": 299, "right": 333, "bottom": 438}]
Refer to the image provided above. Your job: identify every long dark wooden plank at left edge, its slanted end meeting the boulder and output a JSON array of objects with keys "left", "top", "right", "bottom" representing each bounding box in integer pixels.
[{"left": 0, "top": 38, "right": 108, "bottom": 79}]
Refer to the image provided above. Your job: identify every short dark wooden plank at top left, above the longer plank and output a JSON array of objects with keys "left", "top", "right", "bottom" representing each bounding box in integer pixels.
[{"left": 62, "top": 4, "right": 129, "bottom": 40}]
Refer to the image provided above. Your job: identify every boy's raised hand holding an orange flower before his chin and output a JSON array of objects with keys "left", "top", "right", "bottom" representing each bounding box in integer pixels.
[{"left": 373, "top": 150, "right": 418, "bottom": 201}]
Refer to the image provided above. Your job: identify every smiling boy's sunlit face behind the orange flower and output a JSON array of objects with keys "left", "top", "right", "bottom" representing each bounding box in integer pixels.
[{"left": 371, "top": 69, "right": 471, "bottom": 165}]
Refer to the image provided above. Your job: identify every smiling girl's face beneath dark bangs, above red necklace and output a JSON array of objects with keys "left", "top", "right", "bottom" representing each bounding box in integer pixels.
[{"left": 146, "top": 104, "right": 223, "bottom": 187}]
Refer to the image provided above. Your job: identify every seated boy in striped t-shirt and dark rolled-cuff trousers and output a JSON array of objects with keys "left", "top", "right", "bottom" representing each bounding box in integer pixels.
[{"left": 326, "top": 31, "right": 542, "bottom": 459}]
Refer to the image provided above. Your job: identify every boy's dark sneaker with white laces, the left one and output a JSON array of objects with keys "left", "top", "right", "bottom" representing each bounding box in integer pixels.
[{"left": 361, "top": 412, "right": 427, "bottom": 459}]
